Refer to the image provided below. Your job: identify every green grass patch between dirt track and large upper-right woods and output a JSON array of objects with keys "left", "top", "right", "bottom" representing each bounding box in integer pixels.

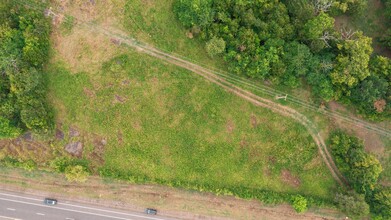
[{"left": 122, "top": 0, "right": 227, "bottom": 70}]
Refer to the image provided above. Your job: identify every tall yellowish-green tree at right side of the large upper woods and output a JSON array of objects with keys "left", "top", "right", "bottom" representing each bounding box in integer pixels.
[{"left": 330, "top": 32, "right": 373, "bottom": 96}]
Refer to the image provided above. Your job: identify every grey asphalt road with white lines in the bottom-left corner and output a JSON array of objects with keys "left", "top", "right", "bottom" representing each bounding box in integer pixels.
[{"left": 0, "top": 191, "right": 175, "bottom": 220}]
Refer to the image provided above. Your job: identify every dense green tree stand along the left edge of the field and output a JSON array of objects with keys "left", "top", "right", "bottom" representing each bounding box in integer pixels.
[{"left": 0, "top": 0, "right": 53, "bottom": 138}]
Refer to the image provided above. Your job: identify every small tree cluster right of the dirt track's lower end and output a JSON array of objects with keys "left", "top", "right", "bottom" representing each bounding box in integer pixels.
[{"left": 329, "top": 131, "right": 391, "bottom": 219}]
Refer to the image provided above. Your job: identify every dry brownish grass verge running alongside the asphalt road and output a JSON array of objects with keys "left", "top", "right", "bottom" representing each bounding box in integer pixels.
[{"left": 0, "top": 168, "right": 342, "bottom": 220}]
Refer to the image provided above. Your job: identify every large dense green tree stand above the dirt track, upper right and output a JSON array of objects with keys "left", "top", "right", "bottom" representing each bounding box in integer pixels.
[{"left": 173, "top": 0, "right": 391, "bottom": 119}]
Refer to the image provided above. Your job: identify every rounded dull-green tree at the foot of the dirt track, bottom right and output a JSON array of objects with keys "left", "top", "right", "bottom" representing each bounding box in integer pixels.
[{"left": 334, "top": 192, "right": 369, "bottom": 217}]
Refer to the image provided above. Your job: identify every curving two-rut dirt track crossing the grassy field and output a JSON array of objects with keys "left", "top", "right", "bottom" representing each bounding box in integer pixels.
[{"left": 91, "top": 26, "right": 347, "bottom": 185}]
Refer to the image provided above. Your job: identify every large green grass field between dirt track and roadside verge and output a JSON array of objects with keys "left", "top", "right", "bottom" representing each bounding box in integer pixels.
[{"left": 48, "top": 51, "right": 336, "bottom": 199}]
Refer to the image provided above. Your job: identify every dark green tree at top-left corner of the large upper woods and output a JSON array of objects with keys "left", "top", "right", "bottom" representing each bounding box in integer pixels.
[{"left": 174, "top": 0, "right": 213, "bottom": 28}]
